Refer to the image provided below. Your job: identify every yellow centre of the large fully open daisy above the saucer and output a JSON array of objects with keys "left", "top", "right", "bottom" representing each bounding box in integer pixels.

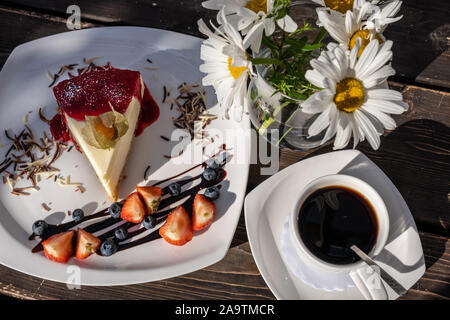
[{"left": 334, "top": 78, "right": 364, "bottom": 113}]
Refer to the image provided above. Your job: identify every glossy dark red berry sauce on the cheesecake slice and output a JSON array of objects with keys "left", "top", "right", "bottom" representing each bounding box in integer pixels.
[{"left": 50, "top": 65, "right": 159, "bottom": 142}]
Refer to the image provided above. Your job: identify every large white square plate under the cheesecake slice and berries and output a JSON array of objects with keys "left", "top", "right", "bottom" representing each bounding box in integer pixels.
[{"left": 0, "top": 27, "right": 250, "bottom": 285}]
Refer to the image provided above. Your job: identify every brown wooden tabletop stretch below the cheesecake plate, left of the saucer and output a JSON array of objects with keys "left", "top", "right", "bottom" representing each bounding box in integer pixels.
[{"left": 0, "top": 244, "right": 273, "bottom": 300}]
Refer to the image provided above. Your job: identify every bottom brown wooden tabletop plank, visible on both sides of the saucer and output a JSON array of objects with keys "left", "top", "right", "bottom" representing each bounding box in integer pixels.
[{"left": 0, "top": 233, "right": 450, "bottom": 300}]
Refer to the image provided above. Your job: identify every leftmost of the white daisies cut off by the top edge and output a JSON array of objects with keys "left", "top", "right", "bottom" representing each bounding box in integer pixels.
[{"left": 202, "top": 0, "right": 297, "bottom": 53}]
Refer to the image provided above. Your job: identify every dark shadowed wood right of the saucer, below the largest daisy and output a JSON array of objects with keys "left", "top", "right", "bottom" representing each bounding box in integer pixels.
[{"left": 358, "top": 120, "right": 450, "bottom": 236}]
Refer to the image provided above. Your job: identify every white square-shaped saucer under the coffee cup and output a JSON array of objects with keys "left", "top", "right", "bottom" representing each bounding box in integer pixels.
[{"left": 245, "top": 150, "right": 425, "bottom": 299}]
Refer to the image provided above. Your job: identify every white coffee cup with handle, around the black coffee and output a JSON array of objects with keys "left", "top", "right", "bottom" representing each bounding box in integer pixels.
[{"left": 289, "top": 174, "right": 389, "bottom": 299}]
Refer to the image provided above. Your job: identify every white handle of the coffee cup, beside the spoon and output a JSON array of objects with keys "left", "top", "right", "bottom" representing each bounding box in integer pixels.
[{"left": 350, "top": 266, "right": 389, "bottom": 300}]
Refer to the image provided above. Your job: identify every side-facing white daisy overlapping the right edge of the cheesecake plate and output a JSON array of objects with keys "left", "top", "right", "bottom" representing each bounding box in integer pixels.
[{"left": 198, "top": 10, "right": 252, "bottom": 121}]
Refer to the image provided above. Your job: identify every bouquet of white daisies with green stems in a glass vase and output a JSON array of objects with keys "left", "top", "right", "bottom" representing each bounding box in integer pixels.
[{"left": 198, "top": 0, "right": 408, "bottom": 149}]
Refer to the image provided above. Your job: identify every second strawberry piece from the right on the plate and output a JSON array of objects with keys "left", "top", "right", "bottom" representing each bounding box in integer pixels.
[{"left": 159, "top": 206, "right": 192, "bottom": 246}]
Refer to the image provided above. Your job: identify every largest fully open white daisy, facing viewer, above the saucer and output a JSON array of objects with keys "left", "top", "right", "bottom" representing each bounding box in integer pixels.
[{"left": 302, "top": 40, "right": 408, "bottom": 150}]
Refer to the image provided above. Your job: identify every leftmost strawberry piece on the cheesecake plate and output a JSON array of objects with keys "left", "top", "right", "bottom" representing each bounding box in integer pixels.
[{"left": 42, "top": 230, "right": 75, "bottom": 262}]
